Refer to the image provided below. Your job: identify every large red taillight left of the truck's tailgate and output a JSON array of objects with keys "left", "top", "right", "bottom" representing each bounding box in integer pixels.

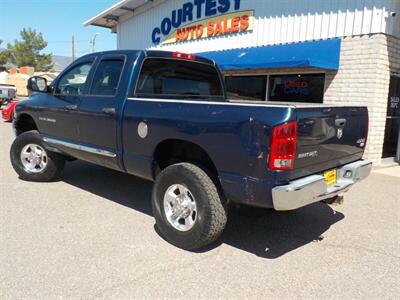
[{"left": 268, "top": 121, "right": 297, "bottom": 170}]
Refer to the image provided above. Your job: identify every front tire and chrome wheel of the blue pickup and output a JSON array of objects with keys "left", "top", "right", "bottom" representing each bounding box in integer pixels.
[{"left": 10, "top": 130, "right": 65, "bottom": 182}]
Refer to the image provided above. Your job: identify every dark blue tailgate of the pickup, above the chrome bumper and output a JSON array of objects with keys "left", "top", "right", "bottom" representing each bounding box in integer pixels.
[{"left": 290, "top": 106, "right": 368, "bottom": 179}]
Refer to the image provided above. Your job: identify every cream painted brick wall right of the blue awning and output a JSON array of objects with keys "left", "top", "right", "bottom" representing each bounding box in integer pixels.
[{"left": 324, "top": 34, "right": 400, "bottom": 164}]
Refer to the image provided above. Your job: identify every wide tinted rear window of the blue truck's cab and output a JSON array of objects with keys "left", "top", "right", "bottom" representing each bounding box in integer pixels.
[{"left": 136, "top": 59, "right": 223, "bottom": 99}]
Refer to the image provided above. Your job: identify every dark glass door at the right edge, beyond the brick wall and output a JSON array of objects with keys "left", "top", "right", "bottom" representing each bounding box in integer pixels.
[{"left": 382, "top": 76, "right": 400, "bottom": 161}]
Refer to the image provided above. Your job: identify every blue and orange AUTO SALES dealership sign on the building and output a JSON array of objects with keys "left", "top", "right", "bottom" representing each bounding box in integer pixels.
[{"left": 151, "top": 0, "right": 254, "bottom": 44}]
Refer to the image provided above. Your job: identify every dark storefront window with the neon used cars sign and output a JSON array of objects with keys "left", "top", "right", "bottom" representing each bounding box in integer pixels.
[{"left": 268, "top": 74, "right": 325, "bottom": 103}]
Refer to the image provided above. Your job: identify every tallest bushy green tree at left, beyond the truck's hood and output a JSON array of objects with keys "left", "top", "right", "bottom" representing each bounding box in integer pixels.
[{"left": 7, "top": 28, "right": 53, "bottom": 72}]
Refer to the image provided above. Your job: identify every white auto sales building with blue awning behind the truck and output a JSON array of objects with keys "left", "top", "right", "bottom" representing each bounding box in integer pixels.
[{"left": 85, "top": 0, "right": 400, "bottom": 164}]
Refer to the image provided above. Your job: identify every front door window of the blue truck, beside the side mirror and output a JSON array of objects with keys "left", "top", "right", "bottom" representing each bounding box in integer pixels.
[{"left": 56, "top": 62, "right": 93, "bottom": 96}]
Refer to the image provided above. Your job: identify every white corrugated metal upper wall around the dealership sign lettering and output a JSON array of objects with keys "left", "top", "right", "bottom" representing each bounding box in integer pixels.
[{"left": 117, "top": 0, "right": 400, "bottom": 53}]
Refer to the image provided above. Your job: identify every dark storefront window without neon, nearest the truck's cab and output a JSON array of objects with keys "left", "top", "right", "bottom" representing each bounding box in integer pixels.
[{"left": 225, "top": 76, "right": 267, "bottom": 101}]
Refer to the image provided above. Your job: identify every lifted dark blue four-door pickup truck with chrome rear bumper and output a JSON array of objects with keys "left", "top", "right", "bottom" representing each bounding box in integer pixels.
[{"left": 10, "top": 50, "right": 371, "bottom": 250}]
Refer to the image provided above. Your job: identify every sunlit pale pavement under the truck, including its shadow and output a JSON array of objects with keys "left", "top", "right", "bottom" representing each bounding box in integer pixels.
[{"left": 0, "top": 123, "right": 400, "bottom": 299}]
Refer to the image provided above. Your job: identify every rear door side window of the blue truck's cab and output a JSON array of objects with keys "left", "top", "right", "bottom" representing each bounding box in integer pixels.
[{"left": 90, "top": 58, "right": 124, "bottom": 96}]
